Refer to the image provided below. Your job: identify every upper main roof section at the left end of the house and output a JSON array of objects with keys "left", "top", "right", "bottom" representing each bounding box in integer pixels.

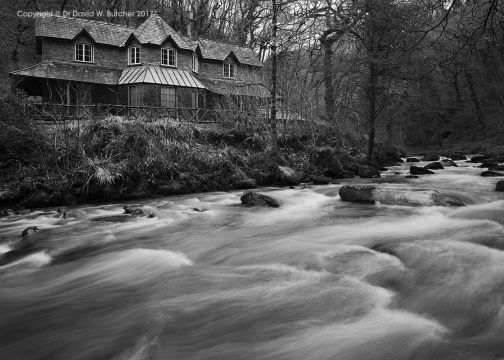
[{"left": 35, "top": 15, "right": 135, "bottom": 46}]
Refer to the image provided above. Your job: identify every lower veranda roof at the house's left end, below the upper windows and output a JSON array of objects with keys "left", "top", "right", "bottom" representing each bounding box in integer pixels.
[{"left": 9, "top": 61, "right": 121, "bottom": 85}]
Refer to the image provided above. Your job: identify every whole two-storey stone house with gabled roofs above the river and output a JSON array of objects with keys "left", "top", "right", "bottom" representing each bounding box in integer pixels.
[{"left": 10, "top": 14, "right": 269, "bottom": 115}]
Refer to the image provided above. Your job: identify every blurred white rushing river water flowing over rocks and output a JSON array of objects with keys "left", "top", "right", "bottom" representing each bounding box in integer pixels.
[{"left": 0, "top": 161, "right": 504, "bottom": 360}]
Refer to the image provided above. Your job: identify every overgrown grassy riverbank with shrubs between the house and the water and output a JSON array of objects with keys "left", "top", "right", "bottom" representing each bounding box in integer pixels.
[{"left": 0, "top": 98, "right": 406, "bottom": 208}]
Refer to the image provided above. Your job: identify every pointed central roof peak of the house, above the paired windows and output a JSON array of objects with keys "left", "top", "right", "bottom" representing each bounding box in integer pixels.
[{"left": 134, "top": 14, "right": 194, "bottom": 50}]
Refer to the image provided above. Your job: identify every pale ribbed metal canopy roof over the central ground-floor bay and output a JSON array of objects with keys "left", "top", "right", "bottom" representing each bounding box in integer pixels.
[{"left": 118, "top": 66, "right": 205, "bottom": 89}]
